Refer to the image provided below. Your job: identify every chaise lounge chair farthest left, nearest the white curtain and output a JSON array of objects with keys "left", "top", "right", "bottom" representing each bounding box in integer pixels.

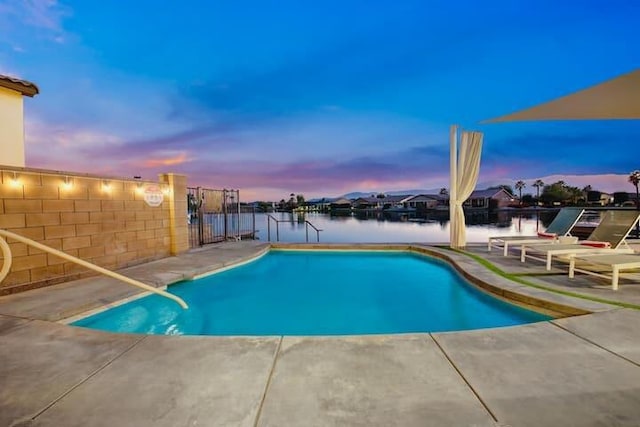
[{"left": 487, "top": 208, "right": 584, "bottom": 256}]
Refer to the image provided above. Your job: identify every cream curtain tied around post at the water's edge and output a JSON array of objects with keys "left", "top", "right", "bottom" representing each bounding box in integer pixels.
[{"left": 449, "top": 126, "right": 483, "bottom": 248}]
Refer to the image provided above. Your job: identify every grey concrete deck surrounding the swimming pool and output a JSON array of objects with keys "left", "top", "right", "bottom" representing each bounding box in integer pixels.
[{"left": 0, "top": 242, "right": 640, "bottom": 427}]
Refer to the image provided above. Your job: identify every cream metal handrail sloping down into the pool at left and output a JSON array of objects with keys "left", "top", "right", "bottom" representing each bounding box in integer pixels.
[{"left": 0, "top": 229, "right": 189, "bottom": 309}]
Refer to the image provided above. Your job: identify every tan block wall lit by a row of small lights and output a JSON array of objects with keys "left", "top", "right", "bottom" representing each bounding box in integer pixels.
[{"left": 0, "top": 168, "right": 188, "bottom": 295}]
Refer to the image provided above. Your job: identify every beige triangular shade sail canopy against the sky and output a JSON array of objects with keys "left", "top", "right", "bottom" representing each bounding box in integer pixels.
[{"left": 483, "top": 69, "right": 640, "bottom": 123}]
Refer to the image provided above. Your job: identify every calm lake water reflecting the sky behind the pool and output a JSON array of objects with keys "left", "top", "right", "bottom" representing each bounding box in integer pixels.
[{"left": 256, "top": 210, "right": 558, "bottom": 243}]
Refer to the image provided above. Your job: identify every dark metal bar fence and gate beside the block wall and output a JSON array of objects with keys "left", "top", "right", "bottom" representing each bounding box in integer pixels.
[{"left": 187, "top": 187, "right": 256, "bottom": 248}]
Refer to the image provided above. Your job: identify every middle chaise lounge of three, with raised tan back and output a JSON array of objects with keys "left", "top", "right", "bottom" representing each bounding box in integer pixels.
[{"left": 520, "top": 211, "right": 640, "bottom": 270}]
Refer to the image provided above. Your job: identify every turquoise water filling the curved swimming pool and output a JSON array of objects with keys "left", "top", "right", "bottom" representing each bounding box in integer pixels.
[{"left": 73, "top": 251, "right": 549, "bottom": 335}]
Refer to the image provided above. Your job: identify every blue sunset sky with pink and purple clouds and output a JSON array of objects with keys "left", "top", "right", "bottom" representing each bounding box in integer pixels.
[{"left": 0, "top": 0, "right": 640, "bottom": 200}]
